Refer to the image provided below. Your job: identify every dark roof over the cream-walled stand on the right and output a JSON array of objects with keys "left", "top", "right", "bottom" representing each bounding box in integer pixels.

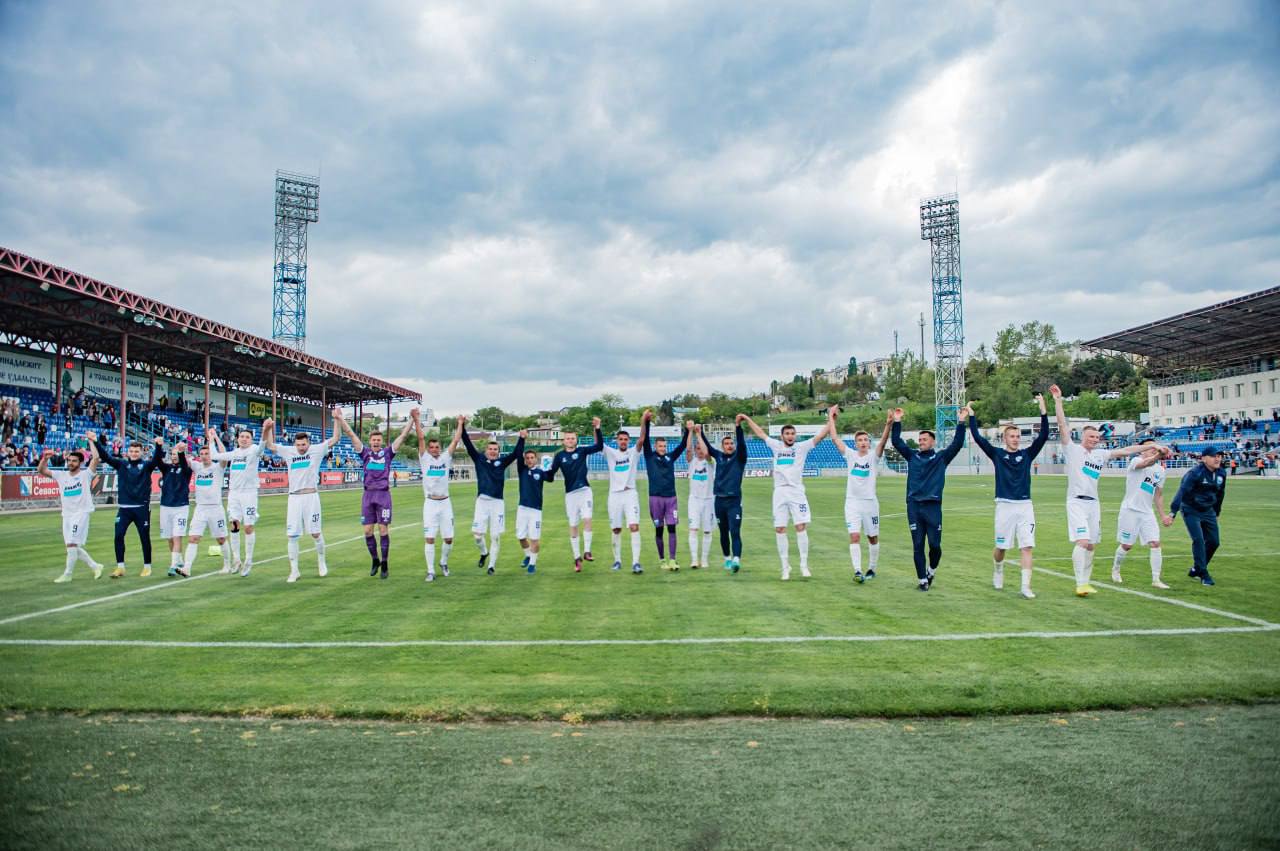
[{"left": 1084, "top": 287, "right": 1280, "bottom": 378}]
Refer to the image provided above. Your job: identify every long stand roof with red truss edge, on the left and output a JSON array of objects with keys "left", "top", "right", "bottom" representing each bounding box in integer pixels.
[{"left": 0, "top": 246, "right": 421, "bottom": 404}]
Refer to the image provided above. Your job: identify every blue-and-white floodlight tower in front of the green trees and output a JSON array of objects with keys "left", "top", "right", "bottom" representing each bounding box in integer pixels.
[{"left": 920, "top": 193, "right": 964, "bottom": 444}]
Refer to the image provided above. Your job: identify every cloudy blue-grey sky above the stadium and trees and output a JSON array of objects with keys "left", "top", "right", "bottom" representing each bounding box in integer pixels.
[{"left": 0, "top": 0, "right": 1280, "bottom": 412}]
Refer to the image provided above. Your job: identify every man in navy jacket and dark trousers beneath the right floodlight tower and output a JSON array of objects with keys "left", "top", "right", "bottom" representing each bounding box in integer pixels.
[{"left": 890, "top": 406, "right": 973, "bottom": 591}]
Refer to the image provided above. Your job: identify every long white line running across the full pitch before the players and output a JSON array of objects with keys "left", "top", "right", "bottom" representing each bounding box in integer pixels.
[{"left": 0, "top": 624, "right": 1280, "bottom": 650}]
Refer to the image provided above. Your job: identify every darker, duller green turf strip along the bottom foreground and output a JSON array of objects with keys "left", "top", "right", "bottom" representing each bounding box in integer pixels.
[{"left": 0, "top": 705, "right": 1280, "bottom": 851}]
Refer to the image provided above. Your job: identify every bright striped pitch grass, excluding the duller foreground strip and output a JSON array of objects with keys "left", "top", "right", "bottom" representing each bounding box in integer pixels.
[{"left": 0, "top": 476, "right": 1280, "bottom": 718}]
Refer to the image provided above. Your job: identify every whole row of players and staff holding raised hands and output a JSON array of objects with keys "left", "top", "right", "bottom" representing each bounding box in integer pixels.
[{"left": 38, "top": 385, "right": 1226, "bottom": 599}]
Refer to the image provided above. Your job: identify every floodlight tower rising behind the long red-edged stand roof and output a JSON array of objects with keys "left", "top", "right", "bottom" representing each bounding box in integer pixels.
[{"left": 271, "top": 171, "right": 320, "bottom": 349}]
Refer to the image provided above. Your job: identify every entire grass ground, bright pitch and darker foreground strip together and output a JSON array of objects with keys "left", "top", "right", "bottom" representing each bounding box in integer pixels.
[{"left": 0, "top": 476, "right": 1280, "bottom": 847}]
